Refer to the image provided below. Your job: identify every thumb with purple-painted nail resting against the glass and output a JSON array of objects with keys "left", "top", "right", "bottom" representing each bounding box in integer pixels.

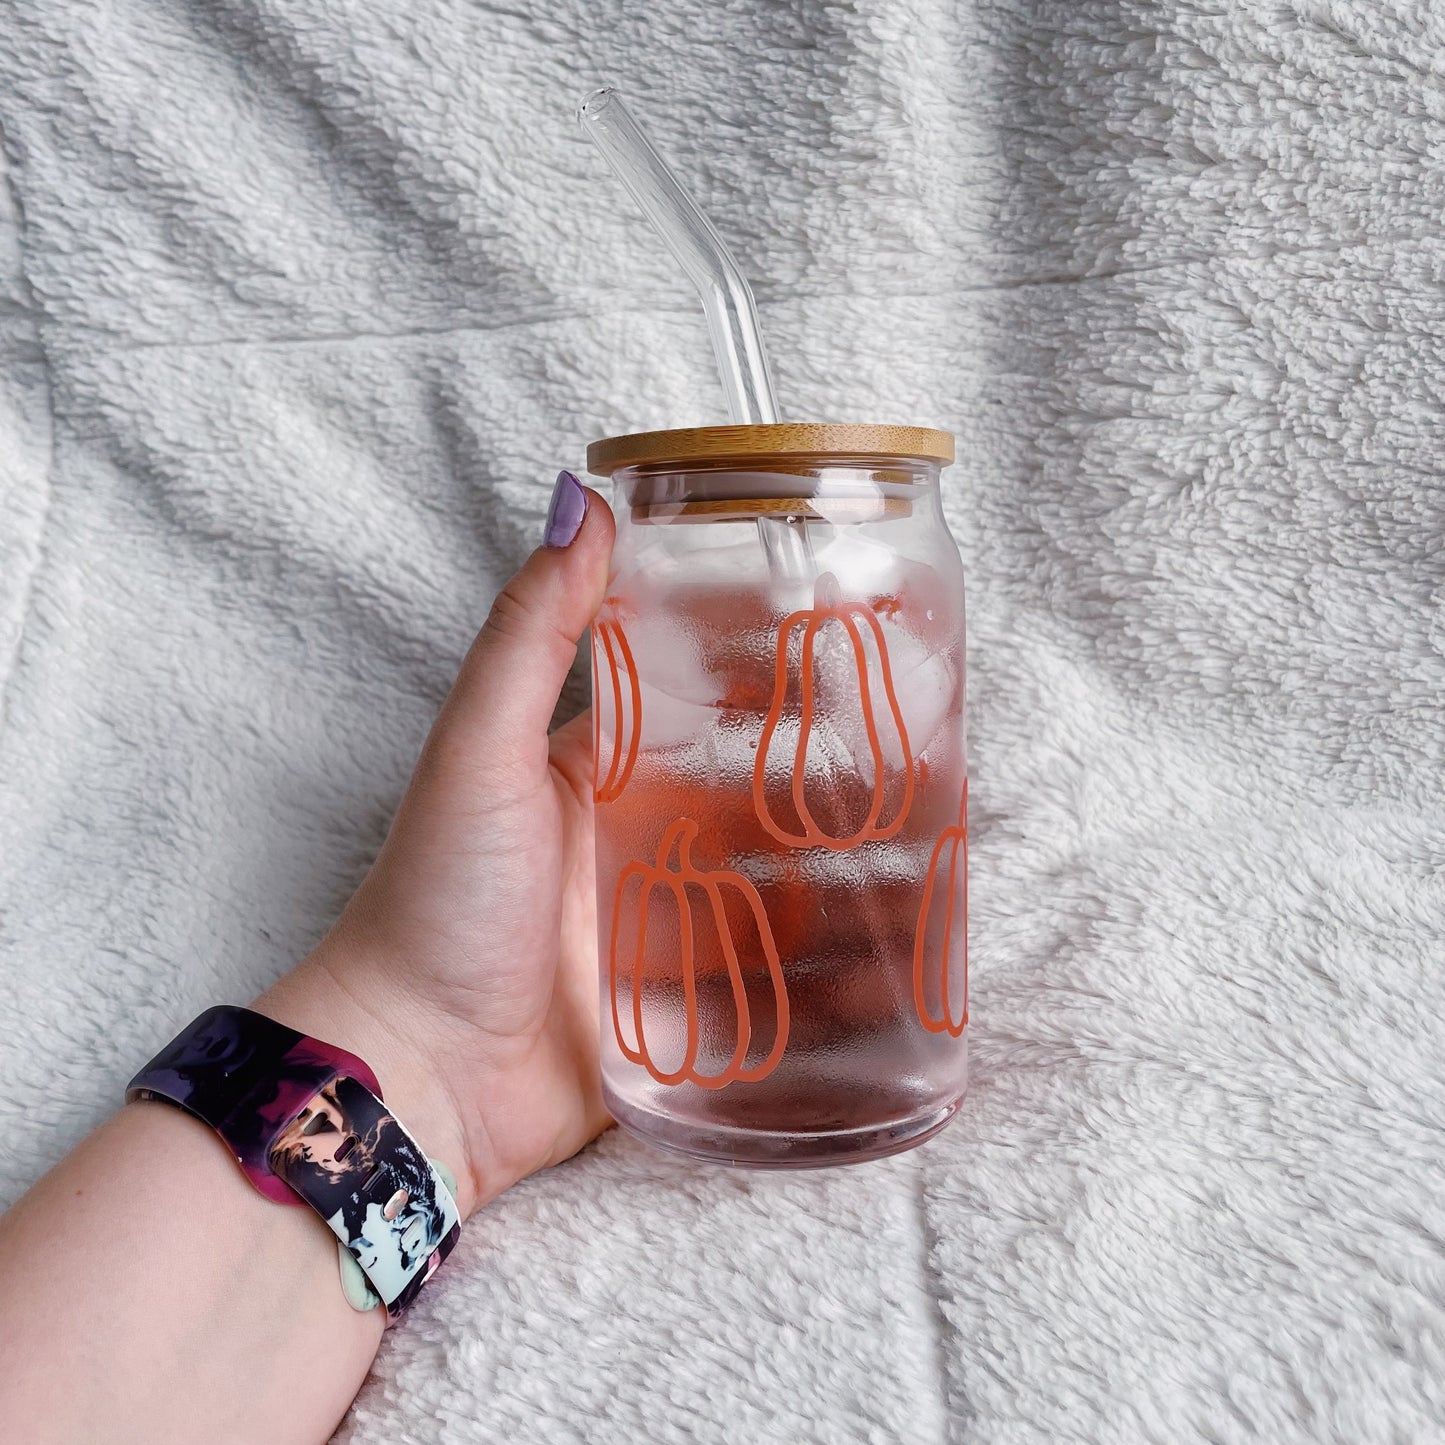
[{"left": 434, "top": 471, "right": 616, "bottom": 795}]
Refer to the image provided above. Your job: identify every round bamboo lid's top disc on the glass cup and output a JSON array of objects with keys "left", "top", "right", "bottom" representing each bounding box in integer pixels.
[{"left": 587, "top": 422, "right": 954, "bottom": 477}]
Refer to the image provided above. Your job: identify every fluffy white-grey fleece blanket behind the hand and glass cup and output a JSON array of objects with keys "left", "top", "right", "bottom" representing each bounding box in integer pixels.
[{"left": 0, "top": 0, "right": 1445, "bottom": 1445}]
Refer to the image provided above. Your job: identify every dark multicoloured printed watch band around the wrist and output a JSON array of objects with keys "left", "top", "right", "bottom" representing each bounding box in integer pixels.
[{"left": 126, "top": 1006, "right": 461, "bottom": 1322}]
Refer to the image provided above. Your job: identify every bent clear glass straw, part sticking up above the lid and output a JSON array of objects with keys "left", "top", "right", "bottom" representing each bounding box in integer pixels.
[{"left": 577, "top": 88, "right": 777, "bottom": 426}]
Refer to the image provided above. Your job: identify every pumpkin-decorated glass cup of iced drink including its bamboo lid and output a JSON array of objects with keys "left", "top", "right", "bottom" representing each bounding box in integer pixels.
[{"left": 588, "top": 425, "right": 968, "bottom": 1168}]
